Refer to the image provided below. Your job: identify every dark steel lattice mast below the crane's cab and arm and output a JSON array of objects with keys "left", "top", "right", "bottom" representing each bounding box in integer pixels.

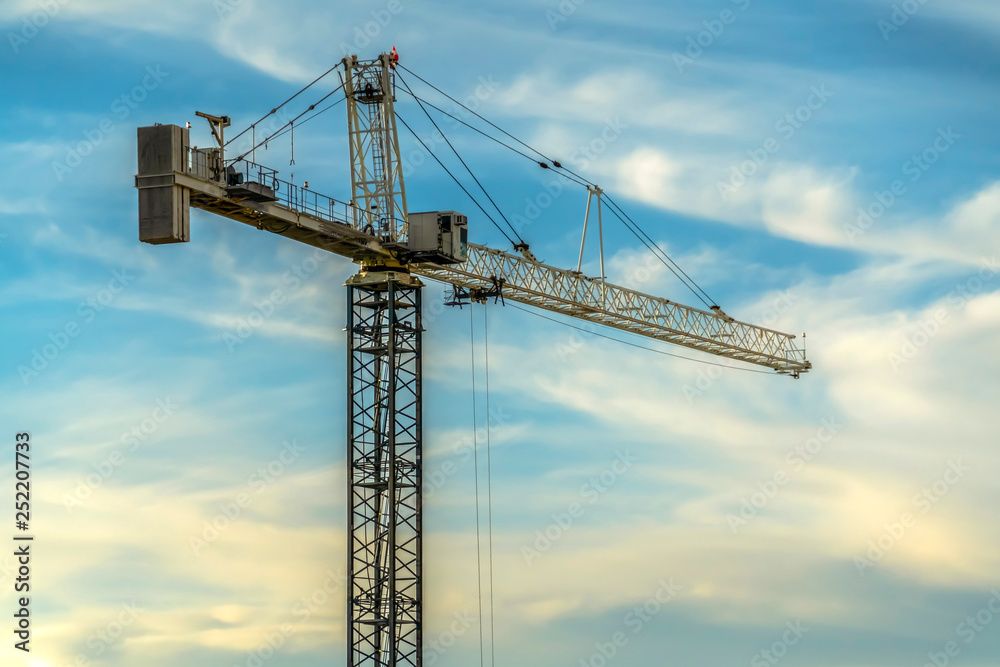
[{"left": 347, "top": 271, "right": 423, "bottom": 667}]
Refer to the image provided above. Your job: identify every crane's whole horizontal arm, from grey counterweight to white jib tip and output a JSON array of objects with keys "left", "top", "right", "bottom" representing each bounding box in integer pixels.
[{"left": 136, "top": 125, "right": 812, "bottom": 376}]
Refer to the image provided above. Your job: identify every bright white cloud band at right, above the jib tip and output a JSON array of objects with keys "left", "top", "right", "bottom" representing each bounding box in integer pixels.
[{"left": 604, "top": 142, "right": 1000, "bottom": 264}]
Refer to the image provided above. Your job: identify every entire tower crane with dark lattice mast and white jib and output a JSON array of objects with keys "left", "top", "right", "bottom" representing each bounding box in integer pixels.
[{"left": 135, "top": 48, "right": 811, "bottom": 667}]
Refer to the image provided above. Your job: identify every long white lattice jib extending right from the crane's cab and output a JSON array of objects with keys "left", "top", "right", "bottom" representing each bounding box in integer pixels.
[{"left": 411, "top": 243, "right": 811, "bottom": 374}]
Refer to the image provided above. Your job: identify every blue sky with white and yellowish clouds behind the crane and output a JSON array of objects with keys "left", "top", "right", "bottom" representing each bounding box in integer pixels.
[{"left": 0, "top": 0, "right": 1000, "bottom": 667}]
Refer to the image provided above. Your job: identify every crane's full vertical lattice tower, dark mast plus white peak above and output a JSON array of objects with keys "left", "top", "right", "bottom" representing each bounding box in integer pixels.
[{"left": 344, "top": 54, "right": 423, "bottom": 667}]
